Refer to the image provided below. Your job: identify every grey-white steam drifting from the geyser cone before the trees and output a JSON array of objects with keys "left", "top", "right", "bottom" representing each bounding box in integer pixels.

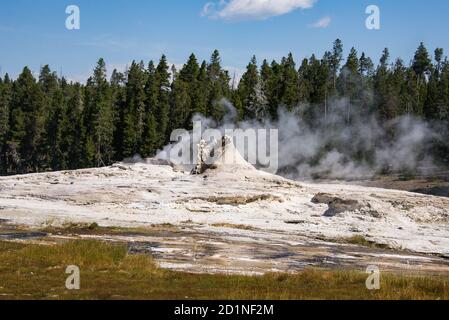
[{"left": 157, "top": 98, "right": 442, "bottom": 179}]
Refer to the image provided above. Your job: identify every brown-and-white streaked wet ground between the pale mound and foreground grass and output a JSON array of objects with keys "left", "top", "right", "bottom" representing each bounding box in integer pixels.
[{"left": 0, "top": 222, "right": 449, "bottom": 275}]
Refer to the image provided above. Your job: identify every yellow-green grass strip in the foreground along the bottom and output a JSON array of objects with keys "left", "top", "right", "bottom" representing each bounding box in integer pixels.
[{"left": 0, "top": 240, "right": 449, "bottom": 300}]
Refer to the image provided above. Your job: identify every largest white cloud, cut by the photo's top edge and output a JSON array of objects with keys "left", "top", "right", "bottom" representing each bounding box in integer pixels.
[{"left": 201, "top": 0, "right": 317, "bottom": 20}]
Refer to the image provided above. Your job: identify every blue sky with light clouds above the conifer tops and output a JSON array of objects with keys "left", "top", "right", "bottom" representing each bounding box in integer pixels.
[{"left": 0, "top": 0, "right": 449, "bottom": 81}]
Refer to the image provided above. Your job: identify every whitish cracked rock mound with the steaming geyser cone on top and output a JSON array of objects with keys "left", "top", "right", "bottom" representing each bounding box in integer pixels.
[{"left": 0, "top": 141, "right": 449, "bottom": 256}]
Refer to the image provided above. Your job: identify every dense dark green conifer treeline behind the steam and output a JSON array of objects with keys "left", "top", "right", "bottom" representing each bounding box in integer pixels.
[{"left": 0, "top": 40, "right": 449, "bottom": 174}]
